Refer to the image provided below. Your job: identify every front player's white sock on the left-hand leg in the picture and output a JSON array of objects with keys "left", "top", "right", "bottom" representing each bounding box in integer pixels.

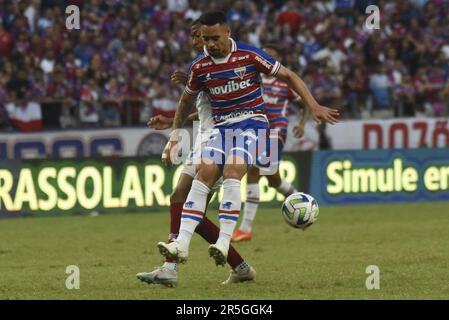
[{"left": 176, "top": 179, "right": 210, "bottom": 248}]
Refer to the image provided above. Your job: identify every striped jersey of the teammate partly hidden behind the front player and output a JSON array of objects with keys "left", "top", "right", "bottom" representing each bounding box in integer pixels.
[{"left": 262, "top": 76, "right": 301, "bottom": 132}]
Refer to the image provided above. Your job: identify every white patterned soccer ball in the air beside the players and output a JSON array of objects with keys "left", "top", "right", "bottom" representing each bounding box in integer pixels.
[{"left": 282, "top": 192, "right": 319, "bottom": 230}]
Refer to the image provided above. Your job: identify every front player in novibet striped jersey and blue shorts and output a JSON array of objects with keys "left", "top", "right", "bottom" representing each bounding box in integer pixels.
[{"left": 158, "top": 11, "right": 338, "bottom": 265}]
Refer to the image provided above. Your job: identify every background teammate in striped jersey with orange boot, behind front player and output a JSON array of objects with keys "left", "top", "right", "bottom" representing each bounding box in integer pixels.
[{"left": 232, "top": 44, "right": 310, "bottom": 242}]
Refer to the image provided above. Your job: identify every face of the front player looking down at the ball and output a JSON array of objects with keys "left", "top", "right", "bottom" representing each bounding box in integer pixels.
[{"left": 201, "top": 24, "right": 231, "bottom": 58}]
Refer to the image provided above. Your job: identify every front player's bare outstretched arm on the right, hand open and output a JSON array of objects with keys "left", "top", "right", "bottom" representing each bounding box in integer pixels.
[{"left": 276, "top": 65, "right": 339, "bottom": 124}]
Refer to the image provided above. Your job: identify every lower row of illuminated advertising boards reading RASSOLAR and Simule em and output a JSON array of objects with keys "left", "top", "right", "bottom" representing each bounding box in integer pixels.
[{"left": 0, "top": 148, "right": 449, "bottom": 217}]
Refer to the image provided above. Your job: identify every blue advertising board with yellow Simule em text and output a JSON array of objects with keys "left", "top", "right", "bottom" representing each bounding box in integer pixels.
[{"left": 310, "top": 148, "right": 449, "bottom": 205}]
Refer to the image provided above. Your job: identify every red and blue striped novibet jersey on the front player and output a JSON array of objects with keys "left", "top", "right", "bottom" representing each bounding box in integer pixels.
[{"left": 186, "top": 39, "right": 281, "bottom": 125}]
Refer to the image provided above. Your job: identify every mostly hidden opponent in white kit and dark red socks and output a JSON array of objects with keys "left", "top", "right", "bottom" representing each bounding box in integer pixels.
[{"left": 137, "top": 20, "right": 256, "bottom": 287}]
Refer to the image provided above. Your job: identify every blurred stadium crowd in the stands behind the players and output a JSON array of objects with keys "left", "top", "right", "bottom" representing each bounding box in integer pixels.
[{"left": 0, "top": 0, "right": 449, "bottom": 131}]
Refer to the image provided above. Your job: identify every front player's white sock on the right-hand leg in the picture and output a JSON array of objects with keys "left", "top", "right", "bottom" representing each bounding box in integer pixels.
[{"left": 217, "top": 179, "right": 242, "bottom": 251}]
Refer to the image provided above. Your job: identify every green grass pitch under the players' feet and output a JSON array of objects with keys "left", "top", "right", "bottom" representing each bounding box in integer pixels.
[{"left": 0, "top": 202, "right": 449, "bottom": 300}]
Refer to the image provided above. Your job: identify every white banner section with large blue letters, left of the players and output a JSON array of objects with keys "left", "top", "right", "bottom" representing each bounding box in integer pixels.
[{"left": 0, "top": 127, "right": 169, "bottom": 160}]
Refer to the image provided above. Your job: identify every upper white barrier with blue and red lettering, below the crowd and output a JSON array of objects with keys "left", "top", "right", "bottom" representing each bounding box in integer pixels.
[{"left": 0, "top": 116, "right": 449, "bottom": 160}]
